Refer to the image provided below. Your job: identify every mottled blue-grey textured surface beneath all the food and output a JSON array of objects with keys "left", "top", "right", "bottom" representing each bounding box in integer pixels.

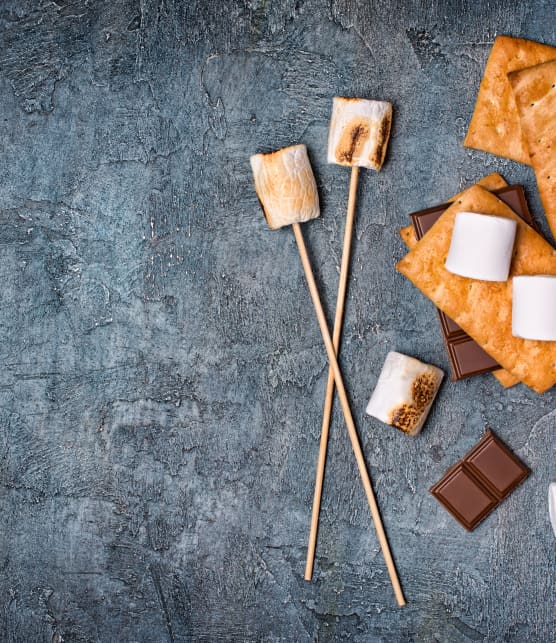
[{"left": 0, "top": 0, "right": 556, "bottom": 643}]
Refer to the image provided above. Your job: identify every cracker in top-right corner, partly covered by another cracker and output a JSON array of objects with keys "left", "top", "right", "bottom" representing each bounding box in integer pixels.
[{"left": 463, "top": 36, "right": 556, "bottom": 164}]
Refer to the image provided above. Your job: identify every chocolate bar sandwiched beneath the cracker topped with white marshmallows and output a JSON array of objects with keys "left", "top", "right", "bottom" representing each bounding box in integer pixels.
[{"left": 409, "top": 185, "right": 536, "bottom": 381}]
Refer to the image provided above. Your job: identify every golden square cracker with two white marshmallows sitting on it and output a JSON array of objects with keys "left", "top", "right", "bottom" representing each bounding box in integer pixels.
[{"left": 397, "top": 186, "right": 556, "bottom": 393}]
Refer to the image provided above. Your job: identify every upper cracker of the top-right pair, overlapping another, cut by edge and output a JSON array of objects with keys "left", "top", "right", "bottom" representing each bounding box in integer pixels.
[{"left": 508, "top": 60, "right": 556, "bottom": 239}]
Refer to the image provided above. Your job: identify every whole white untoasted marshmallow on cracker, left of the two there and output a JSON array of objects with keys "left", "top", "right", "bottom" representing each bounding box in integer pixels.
[{"left": 446, "top": 212, "right": 517, "bottom": 281}]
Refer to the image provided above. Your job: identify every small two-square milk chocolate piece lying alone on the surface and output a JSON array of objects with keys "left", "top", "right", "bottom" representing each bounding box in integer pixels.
[{"left": 429, "top": 429, "right": 530, "bottom": 531}]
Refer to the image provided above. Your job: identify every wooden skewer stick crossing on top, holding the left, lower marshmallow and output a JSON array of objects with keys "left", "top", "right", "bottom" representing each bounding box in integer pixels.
[{"left": 292, "top": 223, "right": 405, "bottom": 605}]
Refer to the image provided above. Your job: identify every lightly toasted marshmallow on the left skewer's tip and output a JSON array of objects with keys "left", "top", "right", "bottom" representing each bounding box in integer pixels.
[{"left": 251, "top": 145, "right": 320, "bottom": 230}]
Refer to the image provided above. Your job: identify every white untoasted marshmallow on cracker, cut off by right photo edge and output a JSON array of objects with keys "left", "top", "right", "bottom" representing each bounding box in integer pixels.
[{"left": 512, "top": 275, "right": 556, "bottom": 342}]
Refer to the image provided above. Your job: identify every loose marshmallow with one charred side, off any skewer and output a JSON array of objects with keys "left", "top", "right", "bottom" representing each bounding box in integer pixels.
[{"left": 367, "top": 351, "right": 444, "bottom": 435}]
